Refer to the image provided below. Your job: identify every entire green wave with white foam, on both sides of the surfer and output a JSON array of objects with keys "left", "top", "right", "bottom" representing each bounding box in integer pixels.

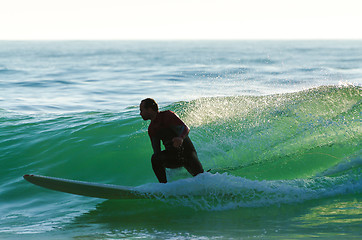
[{"left": 0, "top": 86, "right": 362, "bottom": 210}]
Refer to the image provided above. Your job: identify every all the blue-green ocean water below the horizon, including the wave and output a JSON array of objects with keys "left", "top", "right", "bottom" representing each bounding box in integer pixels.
[{"left": 0, "top": 41, "right": 362, "bottom": 239}]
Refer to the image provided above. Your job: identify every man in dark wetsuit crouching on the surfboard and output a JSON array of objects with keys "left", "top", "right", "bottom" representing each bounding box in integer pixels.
[{"left": 140, "top": 98, "right": 204, "bottom": 183}]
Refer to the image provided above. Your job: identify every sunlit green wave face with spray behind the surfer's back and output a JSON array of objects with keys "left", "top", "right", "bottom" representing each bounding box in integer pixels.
[{"left": 180, "top": 86, "right": 362, "bottom": 179}]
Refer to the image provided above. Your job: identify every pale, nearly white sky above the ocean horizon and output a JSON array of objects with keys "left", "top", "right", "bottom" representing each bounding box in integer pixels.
[{"left": 0, "top": 0, "right": 362, "bottom": 40}]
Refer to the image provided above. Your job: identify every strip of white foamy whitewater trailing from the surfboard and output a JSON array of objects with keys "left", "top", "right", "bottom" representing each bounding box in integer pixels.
[{"left": 135, "top": 172, "right": 362, "bottom": 211}]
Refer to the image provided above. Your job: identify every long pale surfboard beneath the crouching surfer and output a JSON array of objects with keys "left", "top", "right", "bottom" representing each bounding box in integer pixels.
[{"left": 23, "top": 174, "right": 150, "bottom": 199}]
